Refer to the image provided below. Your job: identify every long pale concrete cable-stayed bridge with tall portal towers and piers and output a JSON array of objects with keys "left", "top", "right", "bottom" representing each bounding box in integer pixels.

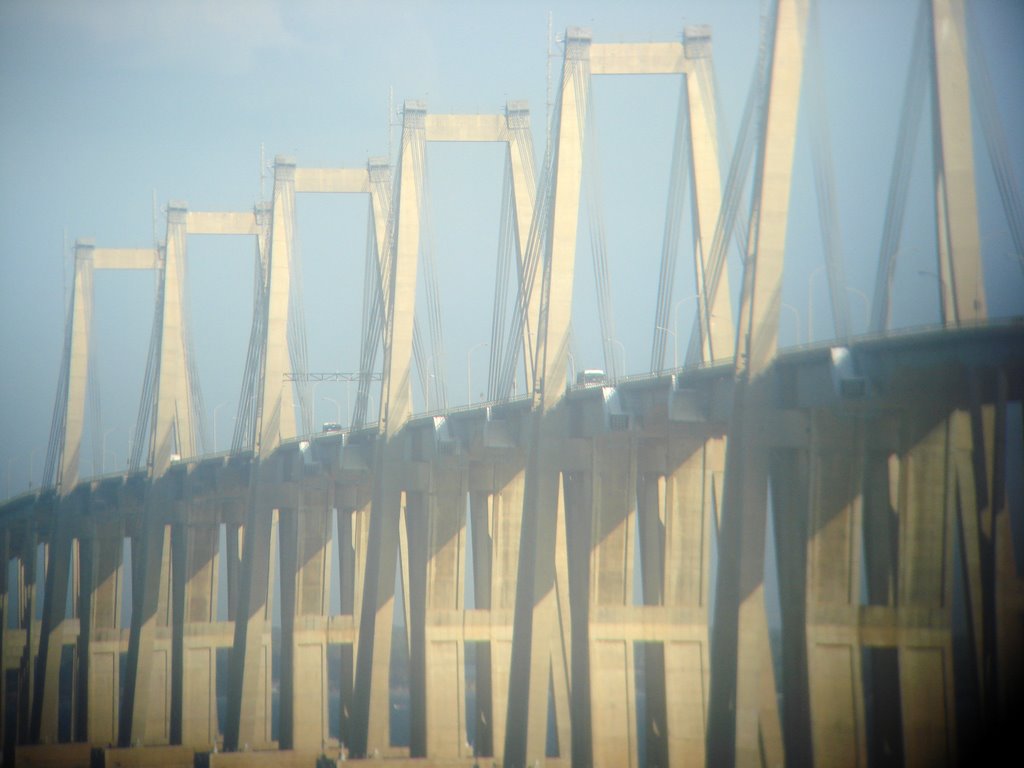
[{"left": 0, "top": 0, "right": 1024, "bottom": 766}]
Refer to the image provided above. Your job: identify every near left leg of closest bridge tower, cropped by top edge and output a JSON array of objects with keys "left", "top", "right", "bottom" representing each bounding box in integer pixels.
[{"left": 708, "top": 0, "right": 808, "bottom": 765}]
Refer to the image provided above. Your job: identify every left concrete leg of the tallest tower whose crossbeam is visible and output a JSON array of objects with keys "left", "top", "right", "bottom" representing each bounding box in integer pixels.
[{"left": 504, "top": 29, "right": 591, "bottom": 765}]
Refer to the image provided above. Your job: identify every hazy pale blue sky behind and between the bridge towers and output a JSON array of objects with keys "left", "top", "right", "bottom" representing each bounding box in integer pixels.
[{"left": 0, "top": 0, "right": 1024, "bottom": 496}]
